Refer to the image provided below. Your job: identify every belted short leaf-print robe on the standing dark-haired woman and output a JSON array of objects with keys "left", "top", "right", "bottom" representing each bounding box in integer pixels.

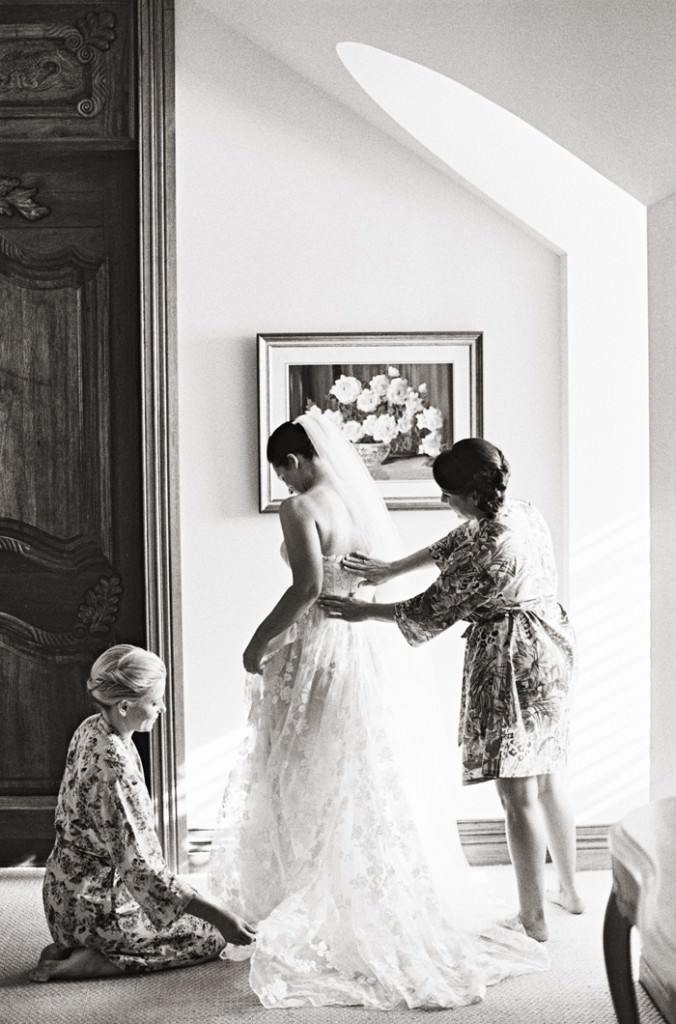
[{"left": 395, "top": 501, "right": 575, "bottom": 783}]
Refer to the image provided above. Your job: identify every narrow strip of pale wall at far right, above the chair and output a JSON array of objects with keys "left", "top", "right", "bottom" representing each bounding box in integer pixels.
[{"left": 648, "top": 195, "right": 676, "bottom": 800}]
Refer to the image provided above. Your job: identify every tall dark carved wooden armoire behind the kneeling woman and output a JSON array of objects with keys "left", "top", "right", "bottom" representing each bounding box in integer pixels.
[{"left": 0, "top": 0, "right": 184, "bottom": 864}]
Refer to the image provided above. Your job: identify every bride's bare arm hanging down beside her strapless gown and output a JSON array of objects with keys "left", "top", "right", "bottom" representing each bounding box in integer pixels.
[{"left": 244, "top": 498, "right": 323, "bottom": 673}]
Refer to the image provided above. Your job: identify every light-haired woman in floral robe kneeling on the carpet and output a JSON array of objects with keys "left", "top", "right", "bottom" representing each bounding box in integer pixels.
[{"left": 30, "top": 644, "right": 254, "bottom": 981}]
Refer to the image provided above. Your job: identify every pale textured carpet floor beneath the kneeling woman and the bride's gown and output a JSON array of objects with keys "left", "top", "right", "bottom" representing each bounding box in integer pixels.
[{"left": 0, "top": 867, "right": 663, "bottom": 1024}]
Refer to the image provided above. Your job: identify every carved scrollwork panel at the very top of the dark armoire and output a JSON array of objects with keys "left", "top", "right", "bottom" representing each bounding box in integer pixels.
[{"left": 0, "top": 3, "right": 130, "bottom": 137}]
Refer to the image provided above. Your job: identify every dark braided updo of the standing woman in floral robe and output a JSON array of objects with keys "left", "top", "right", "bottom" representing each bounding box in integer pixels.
[{"left": 432, "top": 437, "right": 510, "bottom": 516}]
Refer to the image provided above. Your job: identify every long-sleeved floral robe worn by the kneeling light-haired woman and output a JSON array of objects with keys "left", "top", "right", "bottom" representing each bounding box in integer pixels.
[{"left": 43, "top": 715, "right": 225, "bottom": 972}]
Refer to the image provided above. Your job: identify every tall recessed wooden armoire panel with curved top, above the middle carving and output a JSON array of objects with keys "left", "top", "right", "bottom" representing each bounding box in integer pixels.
[{"left": 0, "top": 234, "right": 111, "bottom": 536}]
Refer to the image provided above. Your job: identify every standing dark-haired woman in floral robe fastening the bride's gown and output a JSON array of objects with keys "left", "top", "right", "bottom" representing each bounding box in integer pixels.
[{"left": 322, "top": 437, "right": 584, "bottom": 941}]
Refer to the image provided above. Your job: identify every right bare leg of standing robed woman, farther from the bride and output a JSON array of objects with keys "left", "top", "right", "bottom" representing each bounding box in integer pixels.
[{"left": 538, "top": 773, "right": 585, "bottom": 913}]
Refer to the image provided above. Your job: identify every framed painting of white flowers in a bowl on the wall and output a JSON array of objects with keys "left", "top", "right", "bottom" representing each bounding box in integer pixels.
[{"left": 258, "top": 331, "right": 482, "bottom": 512}]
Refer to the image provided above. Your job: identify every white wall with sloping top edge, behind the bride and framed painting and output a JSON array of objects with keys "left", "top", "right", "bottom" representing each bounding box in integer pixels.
[{"left": 176, "top": 3, "right": 603, "bottom": 827}]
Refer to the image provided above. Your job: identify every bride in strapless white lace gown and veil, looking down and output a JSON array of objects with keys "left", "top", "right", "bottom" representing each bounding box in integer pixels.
[{"left": 209, "top": 414, "right": 549, "bottom": 1010}]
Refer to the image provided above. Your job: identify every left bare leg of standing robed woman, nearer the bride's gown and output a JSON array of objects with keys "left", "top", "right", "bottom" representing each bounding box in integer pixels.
[{"left": 496, "top": 777, "right": 549, "bottom": 942}]
